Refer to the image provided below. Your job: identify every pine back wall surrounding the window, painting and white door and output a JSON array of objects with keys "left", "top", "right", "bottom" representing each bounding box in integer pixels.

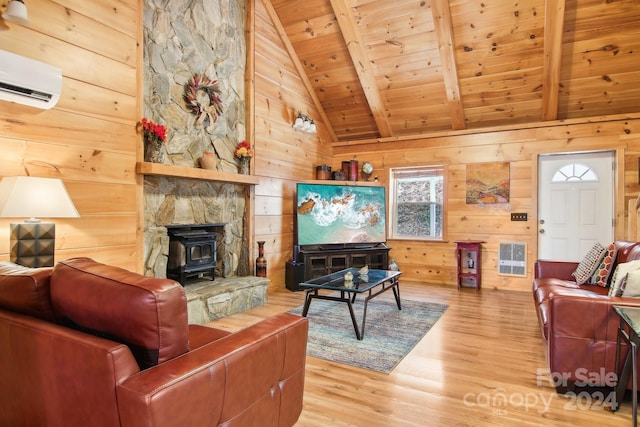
[{"left": 334, "top": 117, "right": 640, "bottom": 291}]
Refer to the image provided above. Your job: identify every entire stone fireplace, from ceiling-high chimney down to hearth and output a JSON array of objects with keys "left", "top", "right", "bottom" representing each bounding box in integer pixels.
[{"left": 139, "top": 0, "right": 268, "bottom": 323}]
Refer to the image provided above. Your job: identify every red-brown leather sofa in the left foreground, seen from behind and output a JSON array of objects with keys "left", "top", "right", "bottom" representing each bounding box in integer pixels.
[{"left": 0, "top": 258, "right": 308, "bottom": 427}]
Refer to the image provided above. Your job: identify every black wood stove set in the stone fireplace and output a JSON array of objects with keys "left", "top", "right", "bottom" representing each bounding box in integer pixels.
[{"left": 167, "top": 224, "right": 224, "bottom": 286}]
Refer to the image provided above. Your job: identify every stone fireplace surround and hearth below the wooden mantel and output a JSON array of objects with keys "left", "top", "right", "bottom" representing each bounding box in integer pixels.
[{"left": 144, "top": 176, "right": 269, "bottom": 324}]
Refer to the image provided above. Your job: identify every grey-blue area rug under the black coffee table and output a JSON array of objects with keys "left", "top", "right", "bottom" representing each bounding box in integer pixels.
[{"left": 290, "top": 292, "right": 447, "bottom": 373}]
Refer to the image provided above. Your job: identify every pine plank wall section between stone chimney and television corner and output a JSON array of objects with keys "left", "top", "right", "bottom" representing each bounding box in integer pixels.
[{"left": 253, "top": 0, "right": 332, "bottom": 289}]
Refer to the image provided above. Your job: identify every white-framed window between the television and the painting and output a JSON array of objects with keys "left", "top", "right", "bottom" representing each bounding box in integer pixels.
[{"left": 389, "top": 166, "right": 444, "bottom": 240}]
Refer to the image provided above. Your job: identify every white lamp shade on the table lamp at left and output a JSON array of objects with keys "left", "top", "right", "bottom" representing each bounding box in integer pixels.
[{"left": 0, "top": 176, "right": 80, "bottom": 218}]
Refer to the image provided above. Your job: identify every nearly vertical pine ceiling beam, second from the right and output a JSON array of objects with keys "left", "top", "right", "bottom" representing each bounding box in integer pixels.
[{"left": 431, "top": 0, "right": 465, "bottom": 130}]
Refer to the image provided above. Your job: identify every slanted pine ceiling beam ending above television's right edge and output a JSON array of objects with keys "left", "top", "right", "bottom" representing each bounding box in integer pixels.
[{"left": 330, "top": 0, "right": 393, "bottom": 138}]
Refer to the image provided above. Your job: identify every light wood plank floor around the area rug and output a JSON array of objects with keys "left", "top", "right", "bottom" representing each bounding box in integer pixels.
[{"left": 206, "top": 282, "right": 631, "bottom": 427}]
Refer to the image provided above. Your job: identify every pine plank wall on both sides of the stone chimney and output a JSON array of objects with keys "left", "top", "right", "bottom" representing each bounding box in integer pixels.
[{"left": 0, "top": 0, "right": 331, "bottom": 287}]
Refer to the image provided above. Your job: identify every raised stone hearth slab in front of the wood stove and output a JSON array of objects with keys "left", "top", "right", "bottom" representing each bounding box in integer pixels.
[{"left": 184, "top": 276, "right": 269, "bottom": 325}]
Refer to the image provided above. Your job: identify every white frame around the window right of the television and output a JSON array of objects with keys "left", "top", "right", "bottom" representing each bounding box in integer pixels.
[{"left": 387, "top": 165, "right": 447, "bottom": 242}]
